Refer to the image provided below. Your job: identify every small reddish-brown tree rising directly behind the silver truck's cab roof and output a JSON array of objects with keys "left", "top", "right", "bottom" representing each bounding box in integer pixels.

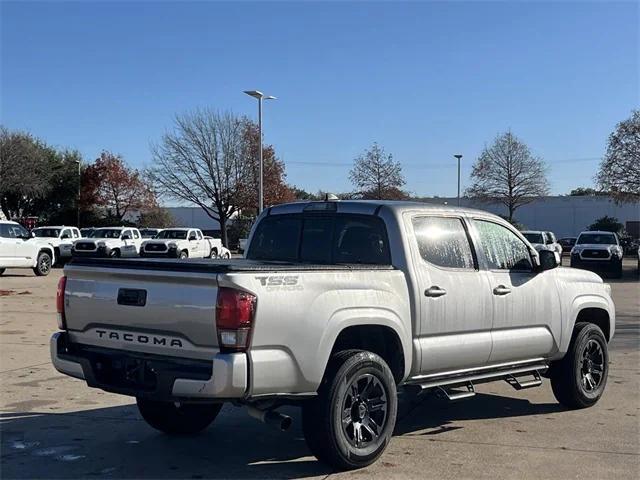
[{"left": 349, "top": 143, "right": 407, "bottom": 200}]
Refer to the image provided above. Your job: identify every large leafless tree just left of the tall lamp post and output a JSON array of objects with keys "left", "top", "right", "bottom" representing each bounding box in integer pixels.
[{"left": 147, "top": 109, "right": 250, "bottom": 245}]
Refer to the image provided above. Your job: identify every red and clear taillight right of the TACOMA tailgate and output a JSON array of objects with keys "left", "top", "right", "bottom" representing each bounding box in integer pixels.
[{"left": 216, "top": 287, "right": 256, "bottom": 352}]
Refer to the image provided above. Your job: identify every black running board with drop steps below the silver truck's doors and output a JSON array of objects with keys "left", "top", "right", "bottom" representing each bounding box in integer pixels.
[{"left": 407, "top": 363, "right": 549, "bottom": 392}]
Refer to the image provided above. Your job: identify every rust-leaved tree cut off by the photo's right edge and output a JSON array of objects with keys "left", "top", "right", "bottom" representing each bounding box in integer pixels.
[{"left": 596, "top": 110, "right": 640, "bottom": 201}]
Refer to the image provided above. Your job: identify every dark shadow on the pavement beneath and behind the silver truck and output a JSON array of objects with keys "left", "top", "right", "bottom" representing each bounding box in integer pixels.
[{"left": 0, "top": 393, "right": 561, "bottom": 479}]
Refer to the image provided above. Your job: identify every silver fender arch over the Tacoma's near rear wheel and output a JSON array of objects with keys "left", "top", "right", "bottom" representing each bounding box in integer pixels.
[{"left": 318, "top": 307, "right": 412, "bottom": 380}]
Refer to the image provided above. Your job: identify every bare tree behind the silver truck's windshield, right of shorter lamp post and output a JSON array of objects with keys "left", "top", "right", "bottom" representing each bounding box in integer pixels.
[{"left": 466, "top": 132, "right": 549, "bottom": 222}]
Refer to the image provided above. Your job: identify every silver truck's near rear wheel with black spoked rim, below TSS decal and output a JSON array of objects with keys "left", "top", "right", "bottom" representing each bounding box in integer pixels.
[{"left": 302, "top": 350, "right": 398, "bottom": 470}]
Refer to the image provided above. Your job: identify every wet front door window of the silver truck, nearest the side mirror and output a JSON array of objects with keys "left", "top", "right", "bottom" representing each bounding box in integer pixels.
[{"left": 474, "top": 220, "right": 533, "bottom": 272}]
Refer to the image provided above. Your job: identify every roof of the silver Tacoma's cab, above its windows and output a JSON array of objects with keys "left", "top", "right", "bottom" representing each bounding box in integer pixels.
[{"left": 267, "top": 200, "right": 499, "bottom": 218}]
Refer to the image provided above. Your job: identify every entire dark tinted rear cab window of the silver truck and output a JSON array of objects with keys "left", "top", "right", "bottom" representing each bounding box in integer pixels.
[{"left": 247, "top": 213, "right": 391, "bottom": 265}]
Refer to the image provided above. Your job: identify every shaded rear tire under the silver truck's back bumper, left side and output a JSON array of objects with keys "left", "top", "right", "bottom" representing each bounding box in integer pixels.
[{"left": 136, "top": 397, "right": 222, "bottom": 435}]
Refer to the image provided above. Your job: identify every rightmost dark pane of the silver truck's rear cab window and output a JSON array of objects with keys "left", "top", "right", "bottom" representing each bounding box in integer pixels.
[{"left": 333, "top": 216, "right": 391, "bottom": 265}]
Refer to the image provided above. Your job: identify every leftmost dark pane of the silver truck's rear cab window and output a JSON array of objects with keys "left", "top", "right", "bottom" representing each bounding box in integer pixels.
[{"left": 247, "top": 215, "right": 302, "bottom": 260}]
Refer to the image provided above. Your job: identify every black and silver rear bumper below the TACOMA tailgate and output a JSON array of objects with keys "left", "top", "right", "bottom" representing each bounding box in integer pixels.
[{"left": 50, "top": 332, "right": 248, "bottom": 401}]
